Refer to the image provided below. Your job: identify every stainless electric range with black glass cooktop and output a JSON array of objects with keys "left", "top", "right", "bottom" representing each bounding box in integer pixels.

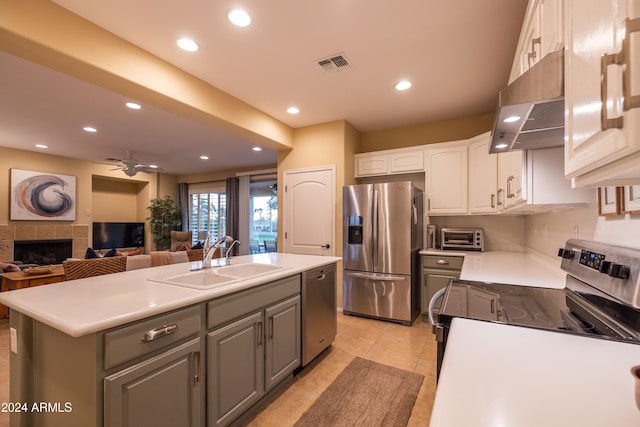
[{"left": 429, "top": 239, "right": 640, "bottom": 376}]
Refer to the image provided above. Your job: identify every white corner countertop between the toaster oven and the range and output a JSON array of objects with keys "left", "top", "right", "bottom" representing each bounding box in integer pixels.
[{"left": 420, "top": 250, "right": 566, "bottom": 289}]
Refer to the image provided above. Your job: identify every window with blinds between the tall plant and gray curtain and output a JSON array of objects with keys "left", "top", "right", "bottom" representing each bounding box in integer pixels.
[{"left": 189, "top": 188, "right": 227, "bottom": 244}]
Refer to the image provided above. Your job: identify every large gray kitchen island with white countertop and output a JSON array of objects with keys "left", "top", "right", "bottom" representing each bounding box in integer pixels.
[{"left": 0, "top": 253, "right": 340, "bottom": 426}]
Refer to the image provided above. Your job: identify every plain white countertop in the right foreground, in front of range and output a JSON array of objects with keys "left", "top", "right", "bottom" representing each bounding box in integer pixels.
[{"left": 430, "top": 318, "right": 640, "bottom": 427}]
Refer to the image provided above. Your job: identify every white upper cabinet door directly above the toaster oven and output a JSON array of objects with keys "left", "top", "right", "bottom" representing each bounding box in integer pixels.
[{"left": 425, "top": 141, "right": 468, "bottom": 215}]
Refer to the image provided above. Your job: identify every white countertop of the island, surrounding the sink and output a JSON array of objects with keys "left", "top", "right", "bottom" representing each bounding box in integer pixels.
[{"left": 0, "top": 253, "right": 342, "bottom": 337}]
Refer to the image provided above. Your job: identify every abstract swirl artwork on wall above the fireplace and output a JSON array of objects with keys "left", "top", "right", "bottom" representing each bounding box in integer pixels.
[{"left": 11, "top": 169, "right": 76, "bottom": 221}]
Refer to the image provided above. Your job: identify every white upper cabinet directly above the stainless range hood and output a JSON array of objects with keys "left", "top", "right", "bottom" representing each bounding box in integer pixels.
[{"left": 509, "top": 0, "right": 564, "bottom": 83}]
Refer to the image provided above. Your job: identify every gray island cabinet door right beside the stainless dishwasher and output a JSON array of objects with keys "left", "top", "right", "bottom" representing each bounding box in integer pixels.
[{"left": 265, "top": 296, "right": 301, "bottom": 390}]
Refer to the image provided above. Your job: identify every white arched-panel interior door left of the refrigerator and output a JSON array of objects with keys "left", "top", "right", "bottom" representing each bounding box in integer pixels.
[{"left": 282, "top": 165, "right": 336, "bottom": 256}]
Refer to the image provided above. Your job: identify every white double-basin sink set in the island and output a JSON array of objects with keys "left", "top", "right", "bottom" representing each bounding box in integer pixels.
[{"left": 148, "top": 263, "right": 283, "bottom": 289}]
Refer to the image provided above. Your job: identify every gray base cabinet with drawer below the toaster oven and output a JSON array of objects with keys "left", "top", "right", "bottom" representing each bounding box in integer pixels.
[{"left": 420, "top": 255, "right": 464, "bottom": 318}]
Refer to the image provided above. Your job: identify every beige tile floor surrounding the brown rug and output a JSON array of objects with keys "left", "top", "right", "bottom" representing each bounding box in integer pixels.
[{"left": 0, "top": 313, "right": 436, "bottom": 427}]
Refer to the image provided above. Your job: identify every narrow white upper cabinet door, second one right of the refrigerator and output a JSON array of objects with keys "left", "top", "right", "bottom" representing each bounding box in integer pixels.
[{"left": 469, "top": 132, "right": 498, "bottom": 214}]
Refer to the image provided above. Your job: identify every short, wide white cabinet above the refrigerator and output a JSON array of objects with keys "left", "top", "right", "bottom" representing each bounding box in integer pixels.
[{"left": 355, "top": 149, "right": 424, "bottom": 178}]
